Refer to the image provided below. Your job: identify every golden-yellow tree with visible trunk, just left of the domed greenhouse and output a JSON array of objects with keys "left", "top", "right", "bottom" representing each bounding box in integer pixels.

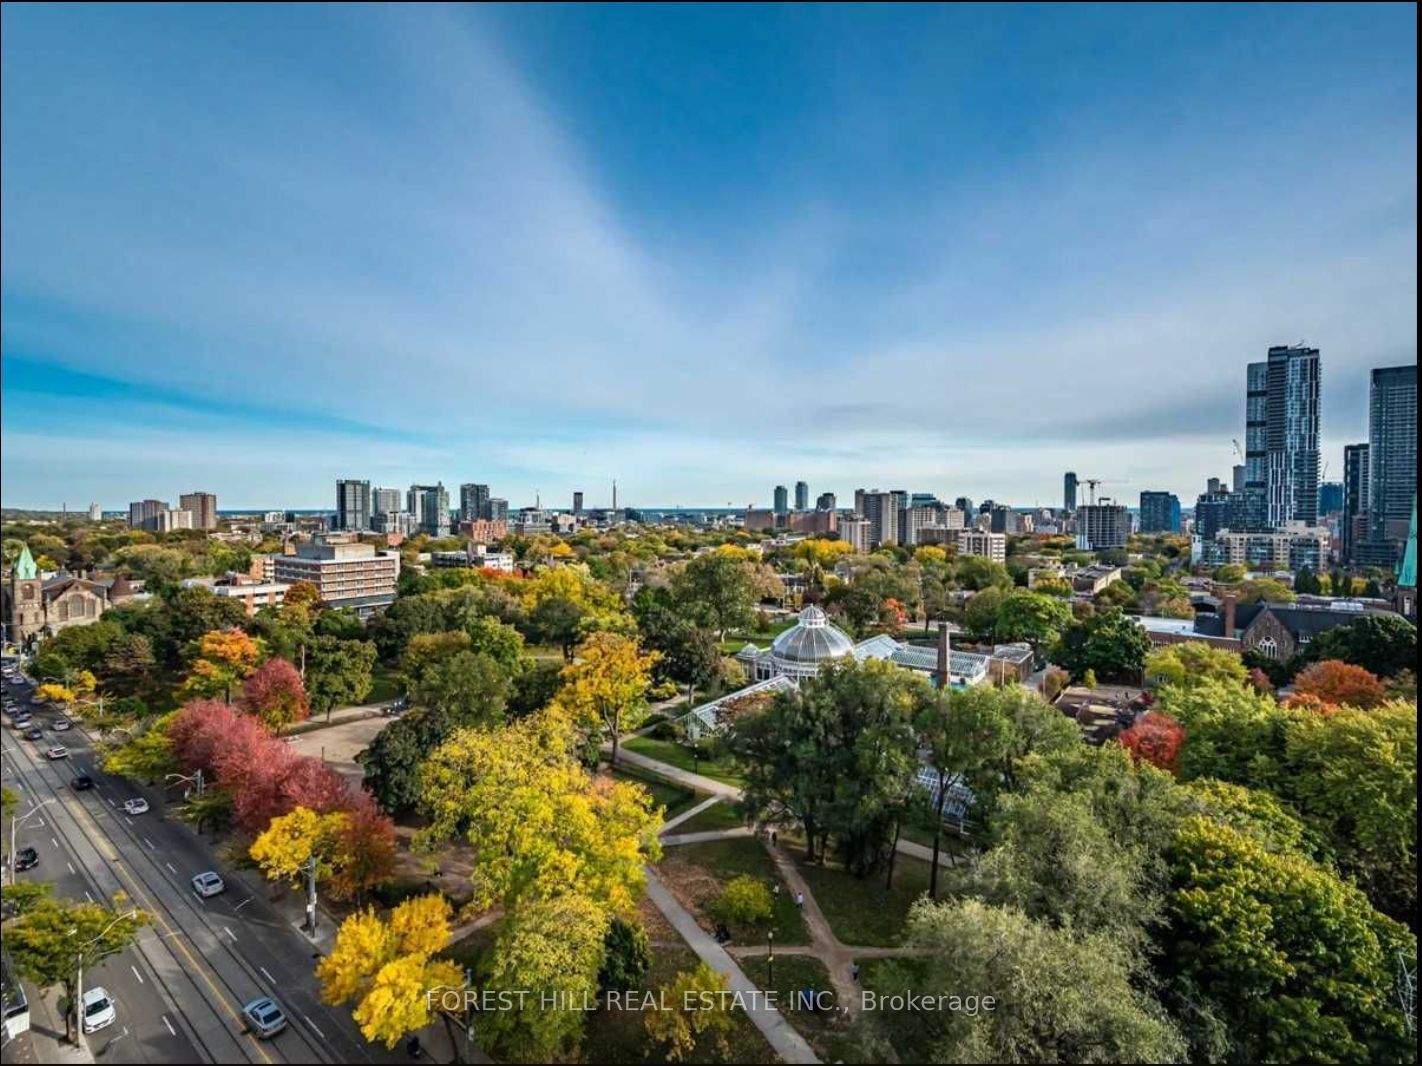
[{"left": 556, "top": 632, "right": 661, "bottom": 766}]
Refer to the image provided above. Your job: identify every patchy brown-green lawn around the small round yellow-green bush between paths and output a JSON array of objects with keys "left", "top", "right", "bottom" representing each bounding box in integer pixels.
[{"left": 661, "top": 837, "right": 809, "bottom": 944}]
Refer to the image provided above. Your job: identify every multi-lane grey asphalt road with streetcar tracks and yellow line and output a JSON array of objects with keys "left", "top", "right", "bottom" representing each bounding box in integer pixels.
[{"left": 0, "top": 670, "right": 408, "bottom": 1063}]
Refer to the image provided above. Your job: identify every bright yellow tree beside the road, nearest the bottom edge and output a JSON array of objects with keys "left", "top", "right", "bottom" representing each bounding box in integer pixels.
[{"left": 316, "top": 895, "right": 464, "bottom": 1048}]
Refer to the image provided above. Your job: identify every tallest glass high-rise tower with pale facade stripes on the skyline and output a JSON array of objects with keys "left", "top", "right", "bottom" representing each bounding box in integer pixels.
[{"left": 1244, "top": 347, "right": 1318, "bottom": 529}]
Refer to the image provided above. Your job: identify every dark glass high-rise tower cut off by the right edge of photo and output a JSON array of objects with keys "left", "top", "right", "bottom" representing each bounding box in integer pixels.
[{"left": 1368, "top": 364, "right": 1418, "bottom": 567}]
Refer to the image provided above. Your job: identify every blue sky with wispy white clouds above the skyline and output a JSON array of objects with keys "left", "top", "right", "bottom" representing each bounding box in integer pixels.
[{"left": 0, "top": 4, "right": 1418, "bottom": 507}]
